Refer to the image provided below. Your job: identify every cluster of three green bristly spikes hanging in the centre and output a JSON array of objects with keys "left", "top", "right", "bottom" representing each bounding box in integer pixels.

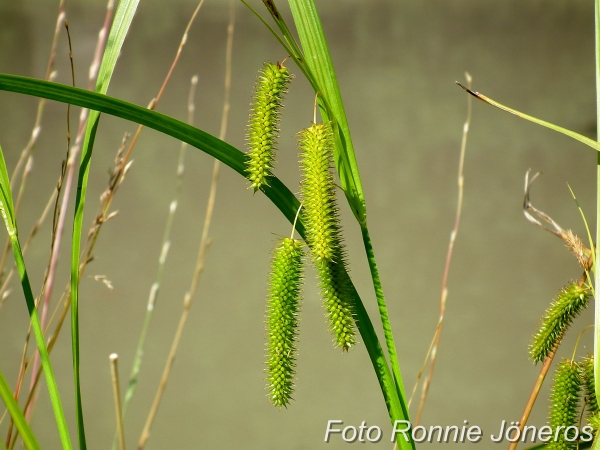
[{"left": 246, "top": 59, "right": 356, "bottom": 407}]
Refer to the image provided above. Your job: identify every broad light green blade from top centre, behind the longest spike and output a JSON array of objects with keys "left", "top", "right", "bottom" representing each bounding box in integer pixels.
[{"left": 289, "top": 0, "right": 367, "bottom": 224}]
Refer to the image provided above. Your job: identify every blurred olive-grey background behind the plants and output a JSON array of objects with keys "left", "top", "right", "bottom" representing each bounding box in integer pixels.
[{"left": 0, "top": 0, "right": 596, "bottom": 450}]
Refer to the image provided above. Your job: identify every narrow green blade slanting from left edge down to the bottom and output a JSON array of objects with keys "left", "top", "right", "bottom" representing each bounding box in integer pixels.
[{"left": 0, "top": 148, "right": 71, "bottom": 449}]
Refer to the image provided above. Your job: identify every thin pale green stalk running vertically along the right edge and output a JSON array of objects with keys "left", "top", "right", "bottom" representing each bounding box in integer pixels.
[{"left": 593, "top": 0, "right": 600, "bottom": 450}]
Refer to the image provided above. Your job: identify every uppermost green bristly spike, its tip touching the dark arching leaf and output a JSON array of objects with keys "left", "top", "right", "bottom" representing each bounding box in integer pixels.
[{"left": 246, "top": 63, "right": 292, "bottom": 192}]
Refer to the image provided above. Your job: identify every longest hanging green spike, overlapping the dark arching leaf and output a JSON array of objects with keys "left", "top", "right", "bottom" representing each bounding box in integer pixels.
[{"left": 299, "top": 123, "right": 356, "bottom": 351}]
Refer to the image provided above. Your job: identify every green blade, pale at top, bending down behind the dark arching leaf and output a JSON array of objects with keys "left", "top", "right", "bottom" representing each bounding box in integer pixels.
[{"left": 71, "top": 0, "right": 139, "bottom": 450}]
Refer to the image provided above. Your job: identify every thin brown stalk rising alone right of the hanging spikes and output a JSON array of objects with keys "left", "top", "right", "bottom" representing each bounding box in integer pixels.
[{"left": 414, "top": 73, "right": 472, "bottom": 426}]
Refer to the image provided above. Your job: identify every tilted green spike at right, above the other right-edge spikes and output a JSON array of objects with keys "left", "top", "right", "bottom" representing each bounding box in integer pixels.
[{"left": 529, "top": 282, "right": 590, "bottom": 363}]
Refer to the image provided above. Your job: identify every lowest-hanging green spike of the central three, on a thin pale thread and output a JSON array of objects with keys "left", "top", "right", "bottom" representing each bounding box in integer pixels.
[{"left": 266, "top": 238, "right": 303, "bottom": 406}]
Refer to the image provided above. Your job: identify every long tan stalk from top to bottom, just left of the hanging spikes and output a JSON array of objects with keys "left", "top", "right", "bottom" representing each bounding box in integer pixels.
[{"left": 137, "top": 0, "right": 235, "bottom": 450}]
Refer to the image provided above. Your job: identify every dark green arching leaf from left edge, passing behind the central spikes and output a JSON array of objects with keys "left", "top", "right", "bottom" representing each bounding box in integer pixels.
[{"left": 0, "top": 74, "right": 408, "bottom": 430}]
